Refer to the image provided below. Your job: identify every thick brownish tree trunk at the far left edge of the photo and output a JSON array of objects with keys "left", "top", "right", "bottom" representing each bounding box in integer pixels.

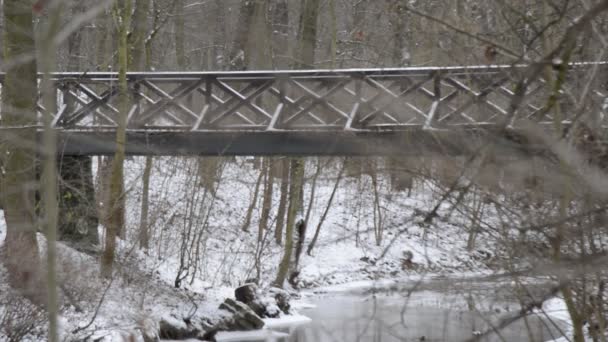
[{"left": 0, "top": 0, "right": 46, "bottom": 304}]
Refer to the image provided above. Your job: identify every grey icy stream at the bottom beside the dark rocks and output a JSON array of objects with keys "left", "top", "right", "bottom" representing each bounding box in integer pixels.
[{"left": 289, "top": 280, "right": 567, "bottom": 342}]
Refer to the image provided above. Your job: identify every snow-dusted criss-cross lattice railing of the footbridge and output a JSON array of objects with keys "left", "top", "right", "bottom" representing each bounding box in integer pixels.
[{"left": 2, "top": 63, "right": 608, "bottom": 132}]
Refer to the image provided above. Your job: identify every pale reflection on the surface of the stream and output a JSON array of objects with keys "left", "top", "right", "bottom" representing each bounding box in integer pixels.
[{"left": 290, "top": 292, "right": 563, "bottom": 342}]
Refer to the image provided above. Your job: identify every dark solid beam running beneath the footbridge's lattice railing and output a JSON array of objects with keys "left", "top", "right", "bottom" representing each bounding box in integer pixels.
[{"left": 51, "top": 128, "right": 548, "bottom": 156}]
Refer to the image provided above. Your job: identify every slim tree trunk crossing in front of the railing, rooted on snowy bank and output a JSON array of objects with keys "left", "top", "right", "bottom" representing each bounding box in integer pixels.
[{"left": 101, "top": 0, "right": 131, "bottom": 277}]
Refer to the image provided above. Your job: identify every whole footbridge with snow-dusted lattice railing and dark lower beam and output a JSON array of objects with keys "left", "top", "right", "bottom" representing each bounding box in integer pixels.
[{"left": 0, "top": 63, "right": 608, "bottom": 155}]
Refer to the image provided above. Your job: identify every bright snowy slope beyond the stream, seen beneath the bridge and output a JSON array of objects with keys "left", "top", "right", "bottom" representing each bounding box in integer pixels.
[{"left": 119, "top": 159, "right": 495, "bottom": 292}]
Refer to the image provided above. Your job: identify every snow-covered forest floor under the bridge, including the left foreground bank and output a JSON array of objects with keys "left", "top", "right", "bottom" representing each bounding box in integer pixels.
[{"left": 0, "top": 158, "right": 560, "bottom": 341}]
